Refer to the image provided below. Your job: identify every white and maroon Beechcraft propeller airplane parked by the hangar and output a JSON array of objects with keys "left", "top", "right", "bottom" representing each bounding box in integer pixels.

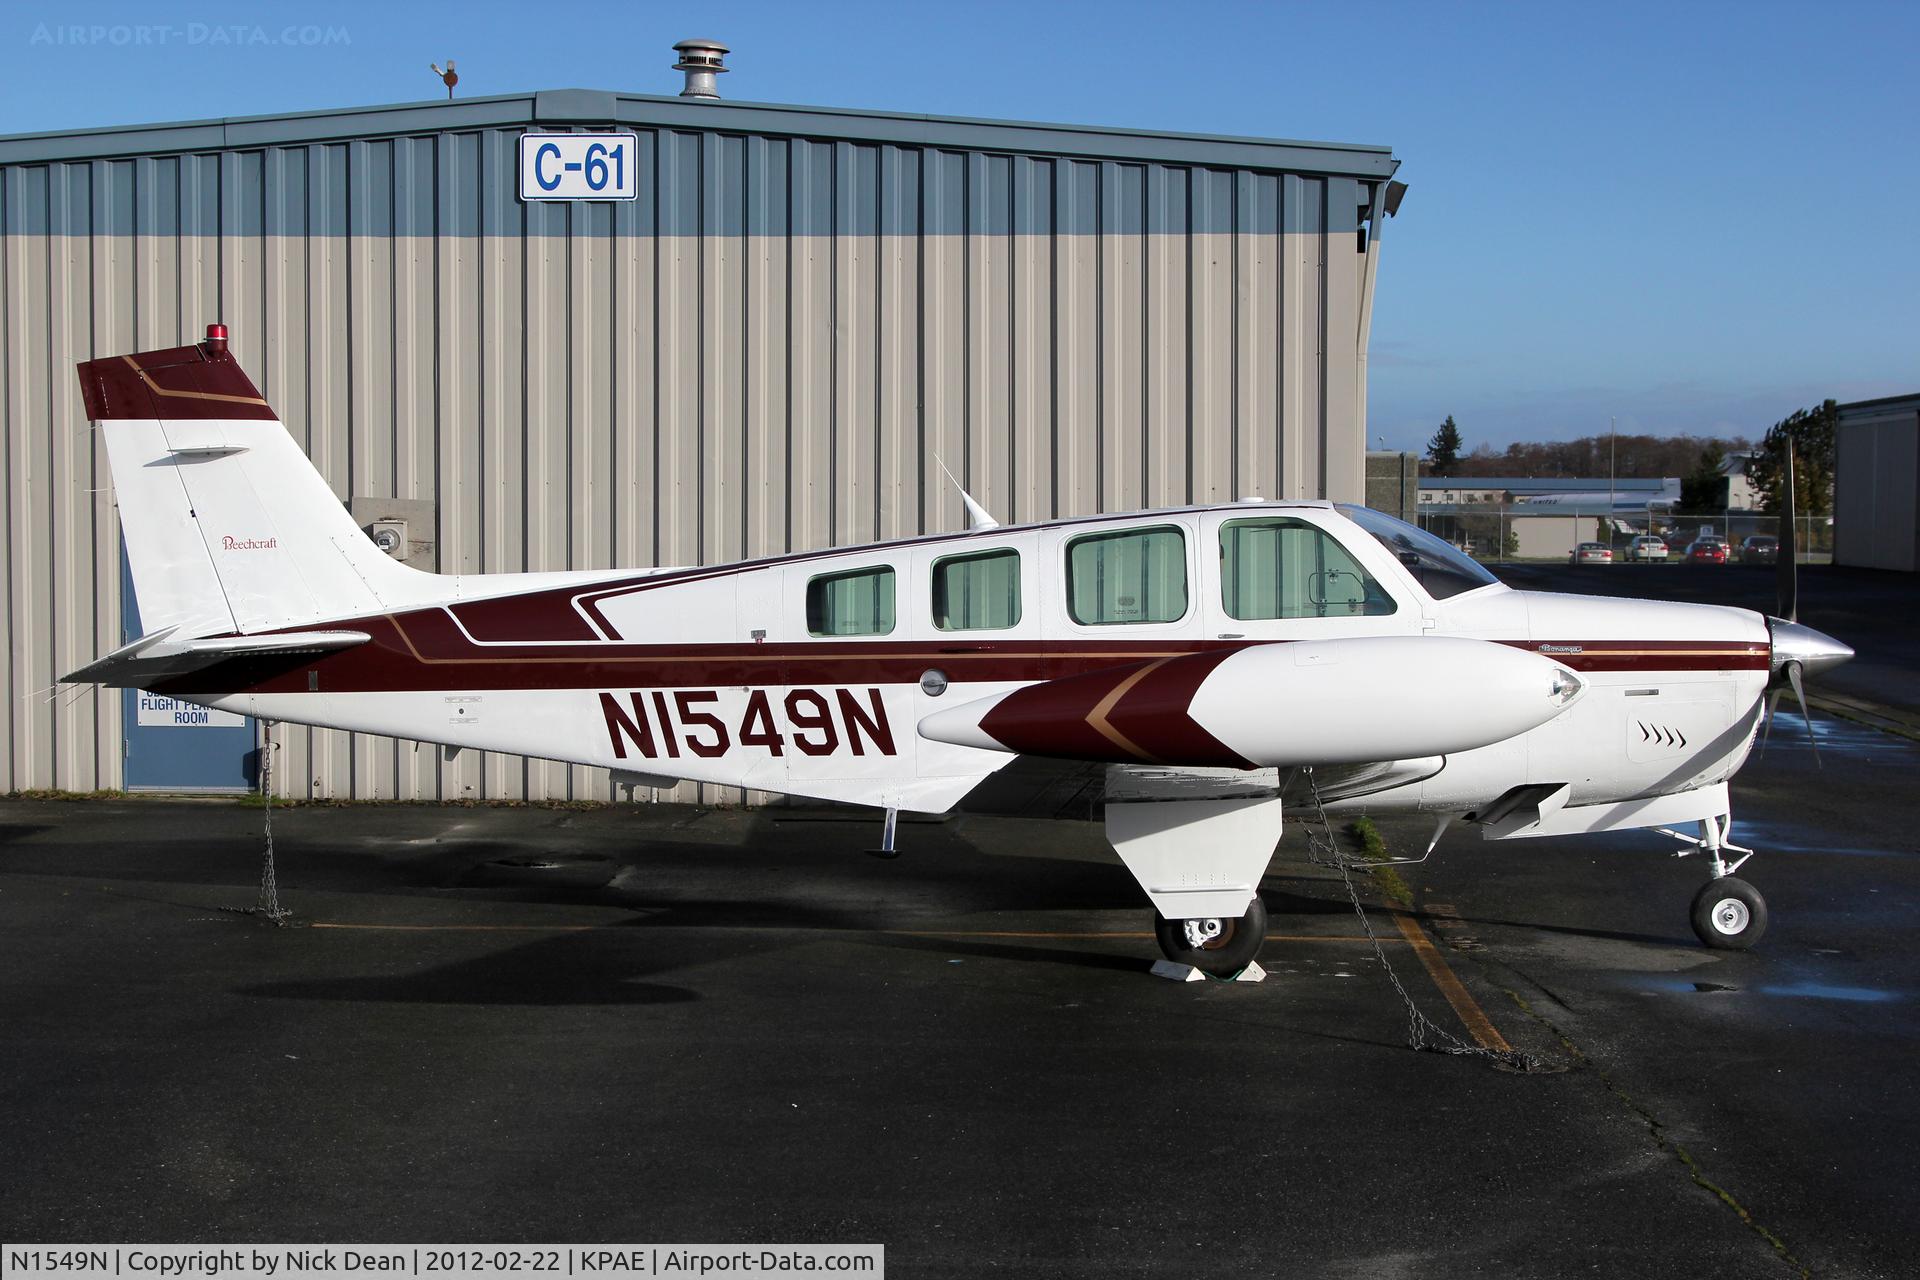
[{"left": 65, "top": 324, "right": 1853, "bottom": 975}]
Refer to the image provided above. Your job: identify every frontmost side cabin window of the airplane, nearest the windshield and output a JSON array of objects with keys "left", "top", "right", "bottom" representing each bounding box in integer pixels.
[{"left": 1219, "top": 516, "right": 1394, "bottom": 622}]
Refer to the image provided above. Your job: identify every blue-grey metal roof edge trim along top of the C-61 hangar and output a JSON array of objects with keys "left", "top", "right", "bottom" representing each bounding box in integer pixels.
[{"left": 0, "top": 88, "right": 1400, "bottom": 178}]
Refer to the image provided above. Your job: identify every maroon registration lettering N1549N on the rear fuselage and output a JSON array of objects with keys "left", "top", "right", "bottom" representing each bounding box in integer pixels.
[{"left": 599, "top": 687, "right": 899, "bottom": 760}]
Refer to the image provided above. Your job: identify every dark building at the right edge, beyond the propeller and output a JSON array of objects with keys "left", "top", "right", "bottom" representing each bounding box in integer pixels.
[{"left": 1834, "top": 393, "right": 1920, "bottom": 572}]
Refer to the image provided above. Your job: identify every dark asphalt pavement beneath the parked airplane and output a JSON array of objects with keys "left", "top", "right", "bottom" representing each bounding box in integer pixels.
[{"left": 0, "top": 568, "right": 1920, "bottom": 1276}]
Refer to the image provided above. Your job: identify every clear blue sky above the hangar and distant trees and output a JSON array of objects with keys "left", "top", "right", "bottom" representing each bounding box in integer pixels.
[{"left": 0, "top": 0, "right": 1920, "bottom": 447}]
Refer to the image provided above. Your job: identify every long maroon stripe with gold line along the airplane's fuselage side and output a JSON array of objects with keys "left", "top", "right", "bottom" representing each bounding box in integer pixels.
[{"left": 154, "top": 608, "right": 1768, "bottom": 702}]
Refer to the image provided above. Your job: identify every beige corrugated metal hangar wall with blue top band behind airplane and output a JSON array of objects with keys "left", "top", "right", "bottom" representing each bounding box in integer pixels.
[{"left": 0, "top": 100, "right": 1390, "bottom": 798}]
